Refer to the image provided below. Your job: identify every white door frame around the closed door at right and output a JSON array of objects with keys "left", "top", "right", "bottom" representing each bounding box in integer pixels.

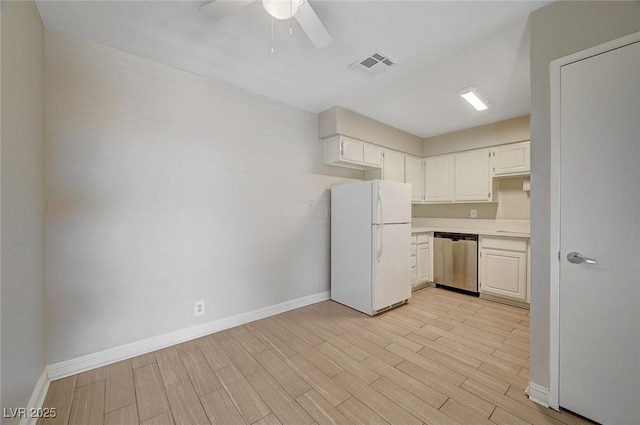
[{"left": 549, "top": 32, "right": 640, "bottom": 410}]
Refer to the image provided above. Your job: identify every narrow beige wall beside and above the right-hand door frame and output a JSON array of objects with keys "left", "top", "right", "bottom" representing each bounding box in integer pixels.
[{"left": 530, "top": 1, "right": 640, "bottom": 388}]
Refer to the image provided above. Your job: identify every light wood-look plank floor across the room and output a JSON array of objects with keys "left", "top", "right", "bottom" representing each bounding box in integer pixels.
[{"left": 38, "top": 288, "right": 587, "bottom": 425}]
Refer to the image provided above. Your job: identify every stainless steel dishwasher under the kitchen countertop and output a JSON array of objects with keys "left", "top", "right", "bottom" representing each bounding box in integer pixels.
[{"left": 433, "top": 232, "right": 478, "bottom": 295}]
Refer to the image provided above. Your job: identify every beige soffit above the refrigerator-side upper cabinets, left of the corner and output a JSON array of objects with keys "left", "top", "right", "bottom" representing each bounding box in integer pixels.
[{"left": 318, "top": 106, "right": 422, "bottom": 156}]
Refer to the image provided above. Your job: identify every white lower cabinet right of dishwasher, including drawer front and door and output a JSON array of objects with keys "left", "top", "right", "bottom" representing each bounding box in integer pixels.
[{"left": 478, "top": 236, "right": 529, "bottom": 303}]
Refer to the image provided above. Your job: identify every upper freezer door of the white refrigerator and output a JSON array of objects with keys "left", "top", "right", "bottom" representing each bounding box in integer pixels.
[{"left": 371, "top": 180, "right": 411, "bottom": 224}]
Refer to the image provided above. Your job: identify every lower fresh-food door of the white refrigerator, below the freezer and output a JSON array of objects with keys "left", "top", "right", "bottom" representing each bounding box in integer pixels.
[{"left": 371, "top": 223, "right": 411, "bottom": 314}]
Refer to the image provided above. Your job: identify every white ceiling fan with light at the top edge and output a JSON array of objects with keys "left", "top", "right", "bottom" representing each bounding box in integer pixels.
[{"left": 200, "top": 0, "right": 333, "bottom": 49}]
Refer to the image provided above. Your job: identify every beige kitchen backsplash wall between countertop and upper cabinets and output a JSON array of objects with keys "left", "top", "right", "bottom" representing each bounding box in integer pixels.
[{"left": 412, "top": 177, "right": 531, "bottom": 220}]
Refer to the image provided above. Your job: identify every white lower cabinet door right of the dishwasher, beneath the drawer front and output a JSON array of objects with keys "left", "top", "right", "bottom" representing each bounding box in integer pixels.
[{"left": 480, "top": 249, "right": 527, "bottom": 301}]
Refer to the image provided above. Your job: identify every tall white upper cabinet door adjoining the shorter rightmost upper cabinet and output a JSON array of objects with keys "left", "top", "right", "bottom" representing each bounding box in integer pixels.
[{"left": 455, "top": 149, "right": 492, "bottom": 201}]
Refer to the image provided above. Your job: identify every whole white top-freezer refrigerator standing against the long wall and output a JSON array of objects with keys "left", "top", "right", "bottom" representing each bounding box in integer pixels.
[{"left": 331, "top": 180, "right": 411, "bottom": 316}]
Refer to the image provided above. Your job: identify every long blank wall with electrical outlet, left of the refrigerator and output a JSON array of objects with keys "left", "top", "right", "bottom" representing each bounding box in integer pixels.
[{"left": 46, "top": 30, "right": 356, "bottom": 363}]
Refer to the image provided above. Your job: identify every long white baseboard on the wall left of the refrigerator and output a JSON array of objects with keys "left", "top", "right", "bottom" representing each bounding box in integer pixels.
[{"left": 47, "top": 291, "right": 330, "bottom": 381}]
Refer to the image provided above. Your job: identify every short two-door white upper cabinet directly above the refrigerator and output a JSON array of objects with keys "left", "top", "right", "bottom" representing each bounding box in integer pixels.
[{"left": 324, "top": 136, "right": 382, "bottom": 170}]
